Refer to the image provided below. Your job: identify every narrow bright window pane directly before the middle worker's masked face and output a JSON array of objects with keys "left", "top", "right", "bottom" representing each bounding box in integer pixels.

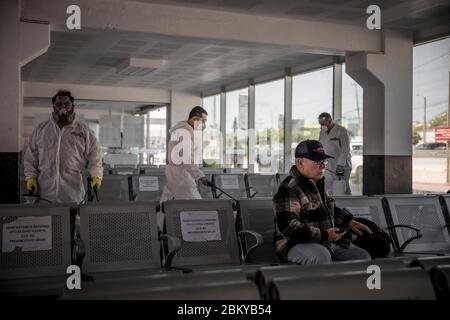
[{"left": 203, "top": 94, "right": 222, "bottom": 168}]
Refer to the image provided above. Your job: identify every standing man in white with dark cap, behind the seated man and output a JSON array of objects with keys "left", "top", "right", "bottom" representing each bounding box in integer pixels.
[{"left": 318, "top": 112, "right": 352, "bottom": 195}]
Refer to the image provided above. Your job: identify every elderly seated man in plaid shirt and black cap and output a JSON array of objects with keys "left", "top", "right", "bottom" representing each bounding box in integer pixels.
[{"left": 273, "top": 140, "right": 372, "bottom": 264}]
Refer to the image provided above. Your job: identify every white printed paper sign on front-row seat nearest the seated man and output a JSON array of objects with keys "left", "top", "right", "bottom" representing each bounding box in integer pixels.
[{"left": 180, "top": 211, "right": 222, "bottom": 242}]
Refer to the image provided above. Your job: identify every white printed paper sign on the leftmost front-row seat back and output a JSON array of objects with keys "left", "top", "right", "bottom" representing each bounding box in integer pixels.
[{"left": 2, "top": 216, "right": 52, "bottom": 252}]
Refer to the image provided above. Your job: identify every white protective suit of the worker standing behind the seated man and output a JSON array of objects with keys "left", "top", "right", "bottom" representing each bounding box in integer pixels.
[{"left": 319, "top": 122, "right": 352, "bottom": 194}]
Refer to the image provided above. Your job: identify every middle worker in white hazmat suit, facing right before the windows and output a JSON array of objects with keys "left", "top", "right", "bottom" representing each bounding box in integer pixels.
[{"left": 161, "top": 106, "right": 209, "bottom": 202}]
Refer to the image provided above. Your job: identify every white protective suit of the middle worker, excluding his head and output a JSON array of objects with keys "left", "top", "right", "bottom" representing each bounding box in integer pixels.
[{"left": 161, "top": 121, "right": 205, "bottom": 202}]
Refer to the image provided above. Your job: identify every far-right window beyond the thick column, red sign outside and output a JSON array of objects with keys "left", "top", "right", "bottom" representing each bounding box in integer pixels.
[{"left": 412, "top": 38, "right": 450, "bottom": 193}]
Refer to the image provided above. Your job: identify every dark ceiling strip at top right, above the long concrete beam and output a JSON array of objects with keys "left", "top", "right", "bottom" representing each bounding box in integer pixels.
[{"left": 130, "top": 0, "right": 450, "bottom": 31}]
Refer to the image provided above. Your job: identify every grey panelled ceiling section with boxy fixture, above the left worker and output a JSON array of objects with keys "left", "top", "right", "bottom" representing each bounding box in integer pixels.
[{"left": 22, "top": 29, "right": 322, "bottom": 92}]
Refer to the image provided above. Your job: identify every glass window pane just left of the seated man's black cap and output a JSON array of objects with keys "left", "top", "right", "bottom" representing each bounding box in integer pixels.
[{"left": 254, "top": 79, "right": 284, "bottom": 172}]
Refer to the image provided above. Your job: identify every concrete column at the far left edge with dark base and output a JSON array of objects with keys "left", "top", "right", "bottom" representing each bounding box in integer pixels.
[{"left": 0, "top": 0, "right": 50, "bottom": 203}]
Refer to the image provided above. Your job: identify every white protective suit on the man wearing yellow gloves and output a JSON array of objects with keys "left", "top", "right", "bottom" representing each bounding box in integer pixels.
[{"left": 24, "top": 118, "right": 103, "bottom": 203}]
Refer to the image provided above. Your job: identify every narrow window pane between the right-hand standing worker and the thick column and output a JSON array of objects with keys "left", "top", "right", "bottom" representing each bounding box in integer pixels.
[{"left": 341, "top": 64, "right": 363, "bottom": 195}]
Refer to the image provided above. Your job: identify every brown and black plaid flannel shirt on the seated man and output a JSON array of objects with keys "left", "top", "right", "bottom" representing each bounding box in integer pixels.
[{"left": 273, "top": 166, "right": 353, "bottom": 259}]
